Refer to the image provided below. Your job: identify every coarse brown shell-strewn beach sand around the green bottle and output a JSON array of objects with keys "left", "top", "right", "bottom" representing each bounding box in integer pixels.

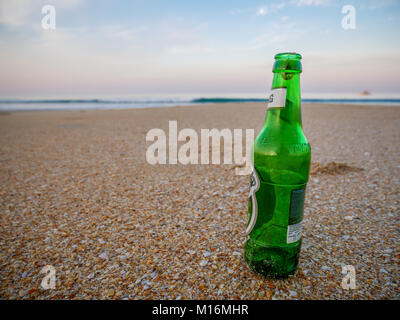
[{"left": 0, "top": 103, "right": 400, "bottom": 299}]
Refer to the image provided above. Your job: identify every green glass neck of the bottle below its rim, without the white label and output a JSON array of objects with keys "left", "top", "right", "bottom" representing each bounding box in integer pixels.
[{"left": 265, "top": 73, "right": 302, "bottom": 127}]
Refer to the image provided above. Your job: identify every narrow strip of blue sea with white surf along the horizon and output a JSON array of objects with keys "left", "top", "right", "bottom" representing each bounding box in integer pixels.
[{"left": 0, "top": 93, "right": 400, "bottom": 111}]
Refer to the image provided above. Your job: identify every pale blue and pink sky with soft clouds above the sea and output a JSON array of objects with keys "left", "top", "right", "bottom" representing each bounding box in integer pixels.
[{"left": 0, "top": 0, "right": 400, "bottom": 97}]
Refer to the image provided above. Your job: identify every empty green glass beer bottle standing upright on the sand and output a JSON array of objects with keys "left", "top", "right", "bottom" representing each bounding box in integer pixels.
[{"left": 244, "top": 53, "right": 311, "bottom": 278}]
